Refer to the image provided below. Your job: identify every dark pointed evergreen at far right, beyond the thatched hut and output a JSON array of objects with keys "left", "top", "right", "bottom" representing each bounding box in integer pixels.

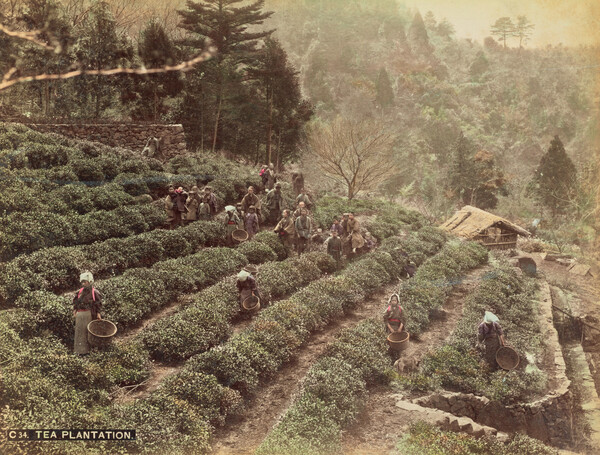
[{"left": 532, "top": 136, "right": 577, "bottom": 215}]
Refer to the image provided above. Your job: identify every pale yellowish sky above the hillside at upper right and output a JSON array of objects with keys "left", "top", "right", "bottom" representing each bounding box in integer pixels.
[{"left": 400, "top": 0, "right": 600, "bottom": 47}]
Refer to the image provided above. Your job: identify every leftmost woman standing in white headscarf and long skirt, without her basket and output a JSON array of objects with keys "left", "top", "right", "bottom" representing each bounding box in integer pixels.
[{"left": 73, "top": 272, "right": 102, "bottom": 355}]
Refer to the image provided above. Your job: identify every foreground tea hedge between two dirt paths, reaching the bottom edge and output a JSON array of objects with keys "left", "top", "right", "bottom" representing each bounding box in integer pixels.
[{"left": 256, "top": 319, "right": 391, "bottom": 455}]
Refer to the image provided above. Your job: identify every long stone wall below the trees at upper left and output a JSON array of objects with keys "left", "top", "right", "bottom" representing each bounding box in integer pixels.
[{"left": 27, "top": 123, "right": 186, "bottom": 158}]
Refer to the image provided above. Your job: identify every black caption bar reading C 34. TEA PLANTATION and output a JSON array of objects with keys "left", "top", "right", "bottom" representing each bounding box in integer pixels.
[{"left": 6, "top": 430, "right": 135, "bottom": 441}]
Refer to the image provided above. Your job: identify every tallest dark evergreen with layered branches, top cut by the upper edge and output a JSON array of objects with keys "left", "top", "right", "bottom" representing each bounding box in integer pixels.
[{"left": 178, "top": 0, "right": 273, "bottom": 150}]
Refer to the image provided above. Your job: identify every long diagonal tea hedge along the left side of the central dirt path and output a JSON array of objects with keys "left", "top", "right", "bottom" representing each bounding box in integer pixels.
[{"left": 186, "top": 252, "right": 396, "bottom": 394}]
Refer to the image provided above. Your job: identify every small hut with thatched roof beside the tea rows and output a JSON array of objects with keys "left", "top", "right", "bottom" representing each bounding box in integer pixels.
[{"left": 440, "top": 205, "right": 531, "bottom": 249}]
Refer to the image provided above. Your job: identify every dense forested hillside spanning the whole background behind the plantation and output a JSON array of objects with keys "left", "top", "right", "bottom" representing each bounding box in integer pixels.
[{"left": 0, "top": 0, "right": 600, "bottom": 253}]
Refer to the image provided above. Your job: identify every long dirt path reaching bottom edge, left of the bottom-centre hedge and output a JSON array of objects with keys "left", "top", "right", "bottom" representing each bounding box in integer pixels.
[{"left": 213, "top": 282, "right": 398, "bottom": 455}]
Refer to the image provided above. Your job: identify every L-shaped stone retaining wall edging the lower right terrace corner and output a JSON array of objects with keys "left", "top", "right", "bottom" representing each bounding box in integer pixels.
[{"left": 413, "top": 281, "right": 573, "bottom": 447}]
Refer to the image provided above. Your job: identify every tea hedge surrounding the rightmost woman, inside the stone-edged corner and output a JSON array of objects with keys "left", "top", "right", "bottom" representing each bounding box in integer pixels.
[{"left": 400, "top": 263, "right": 547, "bottom": 403}]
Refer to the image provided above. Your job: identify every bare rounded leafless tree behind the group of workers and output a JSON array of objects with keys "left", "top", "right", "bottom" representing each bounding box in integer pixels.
[{"left": 308, "top": 117, "right": 396, "bottom": 199}]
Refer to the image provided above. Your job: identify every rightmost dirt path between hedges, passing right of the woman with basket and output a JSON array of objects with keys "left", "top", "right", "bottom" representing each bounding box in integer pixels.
[{"left": 342, "top": 266, "right": 489, "bottom": 455}]
